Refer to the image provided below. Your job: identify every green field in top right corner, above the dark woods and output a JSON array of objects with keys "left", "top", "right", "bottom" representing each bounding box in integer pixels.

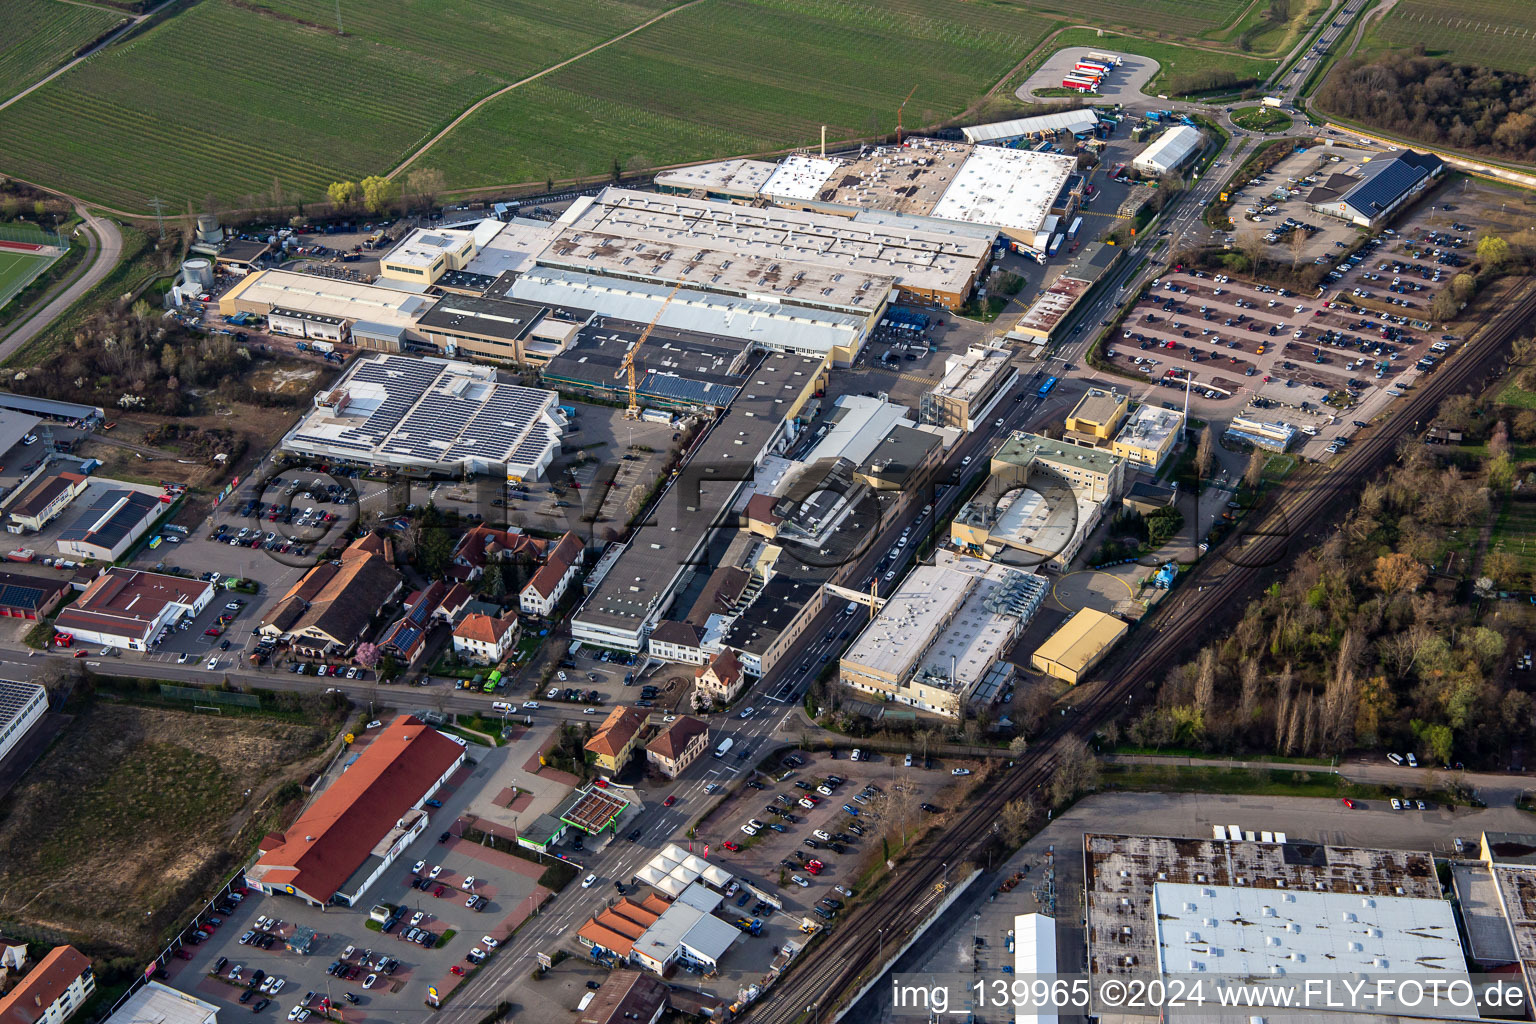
[{"left": 1369, "top": 0, "right": 1536, "bottom": 72}]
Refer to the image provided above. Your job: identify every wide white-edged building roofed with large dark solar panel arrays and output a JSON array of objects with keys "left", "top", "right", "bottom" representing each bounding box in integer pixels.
[{"left": 281, "top": 353, "right": 565, "bottom": 481}]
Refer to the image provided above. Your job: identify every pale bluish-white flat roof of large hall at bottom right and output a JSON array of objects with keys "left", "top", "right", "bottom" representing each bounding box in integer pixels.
[{"left": 1152, "top": 881, "right": 1468, "bottom": 983}]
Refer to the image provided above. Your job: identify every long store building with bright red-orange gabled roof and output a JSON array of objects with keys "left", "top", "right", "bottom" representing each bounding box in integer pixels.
[{"left": 246, "top": 715, "right": 465, "bottom": 906}]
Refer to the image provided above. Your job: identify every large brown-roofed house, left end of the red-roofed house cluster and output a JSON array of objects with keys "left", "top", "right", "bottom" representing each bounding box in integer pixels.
[{"left": 258, "top": 534, "right": 402, "bottom": 657}]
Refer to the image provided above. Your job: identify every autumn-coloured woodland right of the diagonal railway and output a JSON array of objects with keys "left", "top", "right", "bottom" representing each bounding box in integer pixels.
[{"left": 1109, "top": 379, "right": 1536, "bottom": 766}]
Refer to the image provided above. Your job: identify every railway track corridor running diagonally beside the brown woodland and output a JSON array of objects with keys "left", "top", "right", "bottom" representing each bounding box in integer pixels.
[{"left": 746, "top": 277, "right": 1536, "bottom": 1024}]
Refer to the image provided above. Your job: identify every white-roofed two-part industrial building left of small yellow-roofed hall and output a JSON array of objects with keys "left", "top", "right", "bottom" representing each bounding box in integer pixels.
[{"left": 837, "top": 550, "right": 1049, "bottom": 718}]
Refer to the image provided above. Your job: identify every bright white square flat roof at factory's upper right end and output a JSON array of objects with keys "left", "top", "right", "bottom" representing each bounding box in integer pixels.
[{"left": 932, "top": 146, "right": 1077, "bottom": 230}]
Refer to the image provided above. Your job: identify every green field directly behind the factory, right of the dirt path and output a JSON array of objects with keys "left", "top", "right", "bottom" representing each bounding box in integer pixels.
[{"left": 422, "top": 0, "right": 1049, "bottom": 187}]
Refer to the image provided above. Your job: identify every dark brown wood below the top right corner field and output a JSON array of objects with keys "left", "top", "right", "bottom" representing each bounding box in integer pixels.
[{"left": 1315, "top": 46, "right": 1536, "bottom": 161}]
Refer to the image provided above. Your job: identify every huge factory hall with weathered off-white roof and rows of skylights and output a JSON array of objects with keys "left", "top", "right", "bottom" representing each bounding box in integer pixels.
[{"left": 539, "top": 187, "right": 991, "bottom": 315}]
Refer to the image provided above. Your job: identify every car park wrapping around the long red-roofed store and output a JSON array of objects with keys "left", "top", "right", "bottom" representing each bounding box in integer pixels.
[{"left": 172, "top": 749, "right": 547, "bottom": 1021}]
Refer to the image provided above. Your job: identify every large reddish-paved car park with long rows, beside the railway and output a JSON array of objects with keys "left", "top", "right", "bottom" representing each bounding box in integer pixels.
[{"left": 1106, "top": 267, "right": 1452, "bottom": 454}]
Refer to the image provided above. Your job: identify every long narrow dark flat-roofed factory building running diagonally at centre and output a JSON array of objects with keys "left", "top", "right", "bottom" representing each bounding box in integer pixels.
[{"left": 571, "top": 352, "right": 823, "bottom": 651}]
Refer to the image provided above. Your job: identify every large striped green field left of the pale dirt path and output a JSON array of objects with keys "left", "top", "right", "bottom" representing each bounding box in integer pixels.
[{"left": 0, "top": 0, "right": 678, "bottom": 212}]
